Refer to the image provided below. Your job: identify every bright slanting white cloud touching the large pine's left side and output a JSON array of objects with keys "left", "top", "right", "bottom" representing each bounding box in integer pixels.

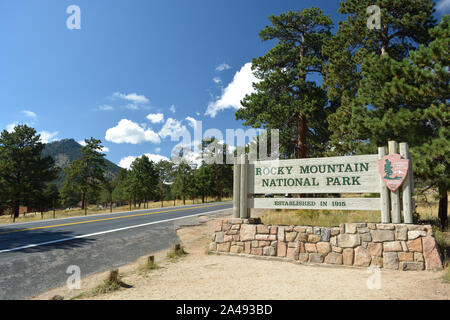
[{"left": 205, "top": 62, "right": 259, "bottom": 118}]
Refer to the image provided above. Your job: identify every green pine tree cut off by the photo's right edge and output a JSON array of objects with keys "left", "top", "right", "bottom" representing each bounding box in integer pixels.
[{"left": 378, "top": 15, "right": 450, "bottom": 229}]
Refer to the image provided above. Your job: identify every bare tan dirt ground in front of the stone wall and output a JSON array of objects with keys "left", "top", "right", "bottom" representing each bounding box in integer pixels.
[{"left": 32, "top": 214, "right": 450, "bottom": 300}]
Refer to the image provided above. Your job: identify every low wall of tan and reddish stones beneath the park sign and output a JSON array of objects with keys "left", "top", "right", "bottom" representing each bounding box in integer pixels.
[{"left": 210, "top": 218, "right": 442, "bottom": 270}]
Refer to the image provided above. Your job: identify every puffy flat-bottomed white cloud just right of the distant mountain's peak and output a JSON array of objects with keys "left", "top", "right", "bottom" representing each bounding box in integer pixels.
[{"left": 105, "top": 119, "right": 161, "bottom": 144}]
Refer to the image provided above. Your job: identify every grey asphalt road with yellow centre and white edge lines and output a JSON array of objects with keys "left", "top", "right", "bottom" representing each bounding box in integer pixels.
[{"left": 0, "top": 202, "right": 232, "bottom": 299}]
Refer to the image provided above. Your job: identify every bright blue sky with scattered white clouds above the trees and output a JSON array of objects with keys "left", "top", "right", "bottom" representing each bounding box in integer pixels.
[{"left": 0, "top": 0, "right": 450, "bottom": 166}]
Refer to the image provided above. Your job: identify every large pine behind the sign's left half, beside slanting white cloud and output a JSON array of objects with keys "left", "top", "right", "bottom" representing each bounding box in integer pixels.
[{"left": 236, "top": 8, "right": 332, "bottom": 158}]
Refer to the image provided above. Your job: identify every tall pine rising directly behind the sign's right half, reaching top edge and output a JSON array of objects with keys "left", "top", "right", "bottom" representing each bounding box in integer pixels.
[{"left": 324, "top": 0, "right": 436, "bottom": 154}]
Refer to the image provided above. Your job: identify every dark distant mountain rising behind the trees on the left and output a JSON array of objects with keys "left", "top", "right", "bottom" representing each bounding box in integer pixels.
[{"left": 42, "top": 139, "right": 121, "bottom": 187}]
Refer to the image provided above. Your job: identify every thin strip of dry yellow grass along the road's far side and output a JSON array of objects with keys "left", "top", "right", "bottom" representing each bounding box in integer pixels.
[{"left": 0, "top": 198, "right": 231, "bottom": 224}]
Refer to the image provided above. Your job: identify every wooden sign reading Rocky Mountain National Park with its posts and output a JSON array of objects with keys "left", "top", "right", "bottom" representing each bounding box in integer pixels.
[{"left": 233, "top": 141, "right": 414, "bottom": 223}]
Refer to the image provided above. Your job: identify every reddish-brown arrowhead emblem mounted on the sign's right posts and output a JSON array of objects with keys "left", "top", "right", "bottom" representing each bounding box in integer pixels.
[{"left": 378, "top": 154, "right": 409, "bottom": 191}]
